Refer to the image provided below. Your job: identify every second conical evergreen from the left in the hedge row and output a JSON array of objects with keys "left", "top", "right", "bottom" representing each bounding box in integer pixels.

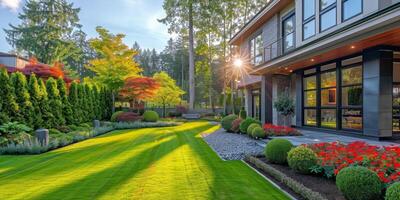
[{"left": 11, "top": 72, "right": 34, "bottom": 126}]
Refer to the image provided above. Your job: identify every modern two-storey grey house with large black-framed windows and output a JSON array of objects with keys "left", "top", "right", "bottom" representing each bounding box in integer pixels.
[{"left": 230, "top": 0, "right": 400, "bottom": 139}]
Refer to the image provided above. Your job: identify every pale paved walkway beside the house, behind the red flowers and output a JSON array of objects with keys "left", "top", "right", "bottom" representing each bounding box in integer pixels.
[{"left": 263, "top": 129, "right": 400, "bottom": 146}]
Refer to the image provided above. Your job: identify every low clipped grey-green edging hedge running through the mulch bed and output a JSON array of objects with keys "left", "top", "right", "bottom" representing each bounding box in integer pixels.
[{"left": 244, "top": 156, "right": 327, "bottom": 200}]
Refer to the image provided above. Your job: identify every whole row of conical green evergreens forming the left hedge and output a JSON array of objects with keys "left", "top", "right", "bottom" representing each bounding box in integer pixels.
[{"left": 0, "top": 69, "right": 112, "bottom": 128}]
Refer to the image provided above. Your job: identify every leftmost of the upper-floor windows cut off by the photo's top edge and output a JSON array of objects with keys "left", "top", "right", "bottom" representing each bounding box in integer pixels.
[{"left": 303, "top": 0, "right": 315, "bottom": 40}]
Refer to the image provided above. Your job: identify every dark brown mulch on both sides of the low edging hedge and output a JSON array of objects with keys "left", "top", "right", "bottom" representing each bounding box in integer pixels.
[{"left": 247, "top": 157, "right": 345, "bottom": 200}]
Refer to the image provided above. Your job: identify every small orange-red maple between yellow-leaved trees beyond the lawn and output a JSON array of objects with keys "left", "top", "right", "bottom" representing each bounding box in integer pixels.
[{"left": 119, "top": 77, "right": 160, "bottom": 102}]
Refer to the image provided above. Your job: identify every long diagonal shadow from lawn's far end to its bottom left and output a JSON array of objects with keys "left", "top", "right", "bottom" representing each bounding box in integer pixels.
[{"left": 31, "top": 124, "right": 212, "bottom": 199}]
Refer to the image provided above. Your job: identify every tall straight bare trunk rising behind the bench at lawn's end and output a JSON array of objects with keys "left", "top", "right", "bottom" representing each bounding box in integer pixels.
[{"left": 189, "top": 1, "right": 195, "bottom": 110}]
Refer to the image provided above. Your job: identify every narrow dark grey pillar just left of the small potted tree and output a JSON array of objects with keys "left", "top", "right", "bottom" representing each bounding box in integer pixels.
[{"left": 260, "top": 74, "right": 272, "bottom": 123}]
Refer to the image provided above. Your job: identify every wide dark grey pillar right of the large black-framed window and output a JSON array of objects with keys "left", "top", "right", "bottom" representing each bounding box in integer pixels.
[{"left": 363, "top": 50, "right": 393, "bottom": 138}]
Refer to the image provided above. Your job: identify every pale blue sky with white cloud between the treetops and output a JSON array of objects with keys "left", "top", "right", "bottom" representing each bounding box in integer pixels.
[{"left": 0, "top": 0, "right": 171, "bottom": 52}]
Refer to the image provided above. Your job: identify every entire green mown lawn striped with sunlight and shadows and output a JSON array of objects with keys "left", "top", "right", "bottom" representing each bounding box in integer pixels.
[{"left": 0, "top": 122, "right": 288, "bottom": 200}]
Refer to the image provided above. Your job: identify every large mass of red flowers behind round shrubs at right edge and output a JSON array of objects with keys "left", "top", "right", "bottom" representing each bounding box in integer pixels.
[{"left": 308, "top": 141, "right": 400, "bottom": 184}]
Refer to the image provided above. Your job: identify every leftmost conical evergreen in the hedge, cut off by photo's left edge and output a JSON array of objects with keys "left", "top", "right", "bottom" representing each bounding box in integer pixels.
[{"left": 0, "top": 69, "right": 19, "bottom": 124}]
